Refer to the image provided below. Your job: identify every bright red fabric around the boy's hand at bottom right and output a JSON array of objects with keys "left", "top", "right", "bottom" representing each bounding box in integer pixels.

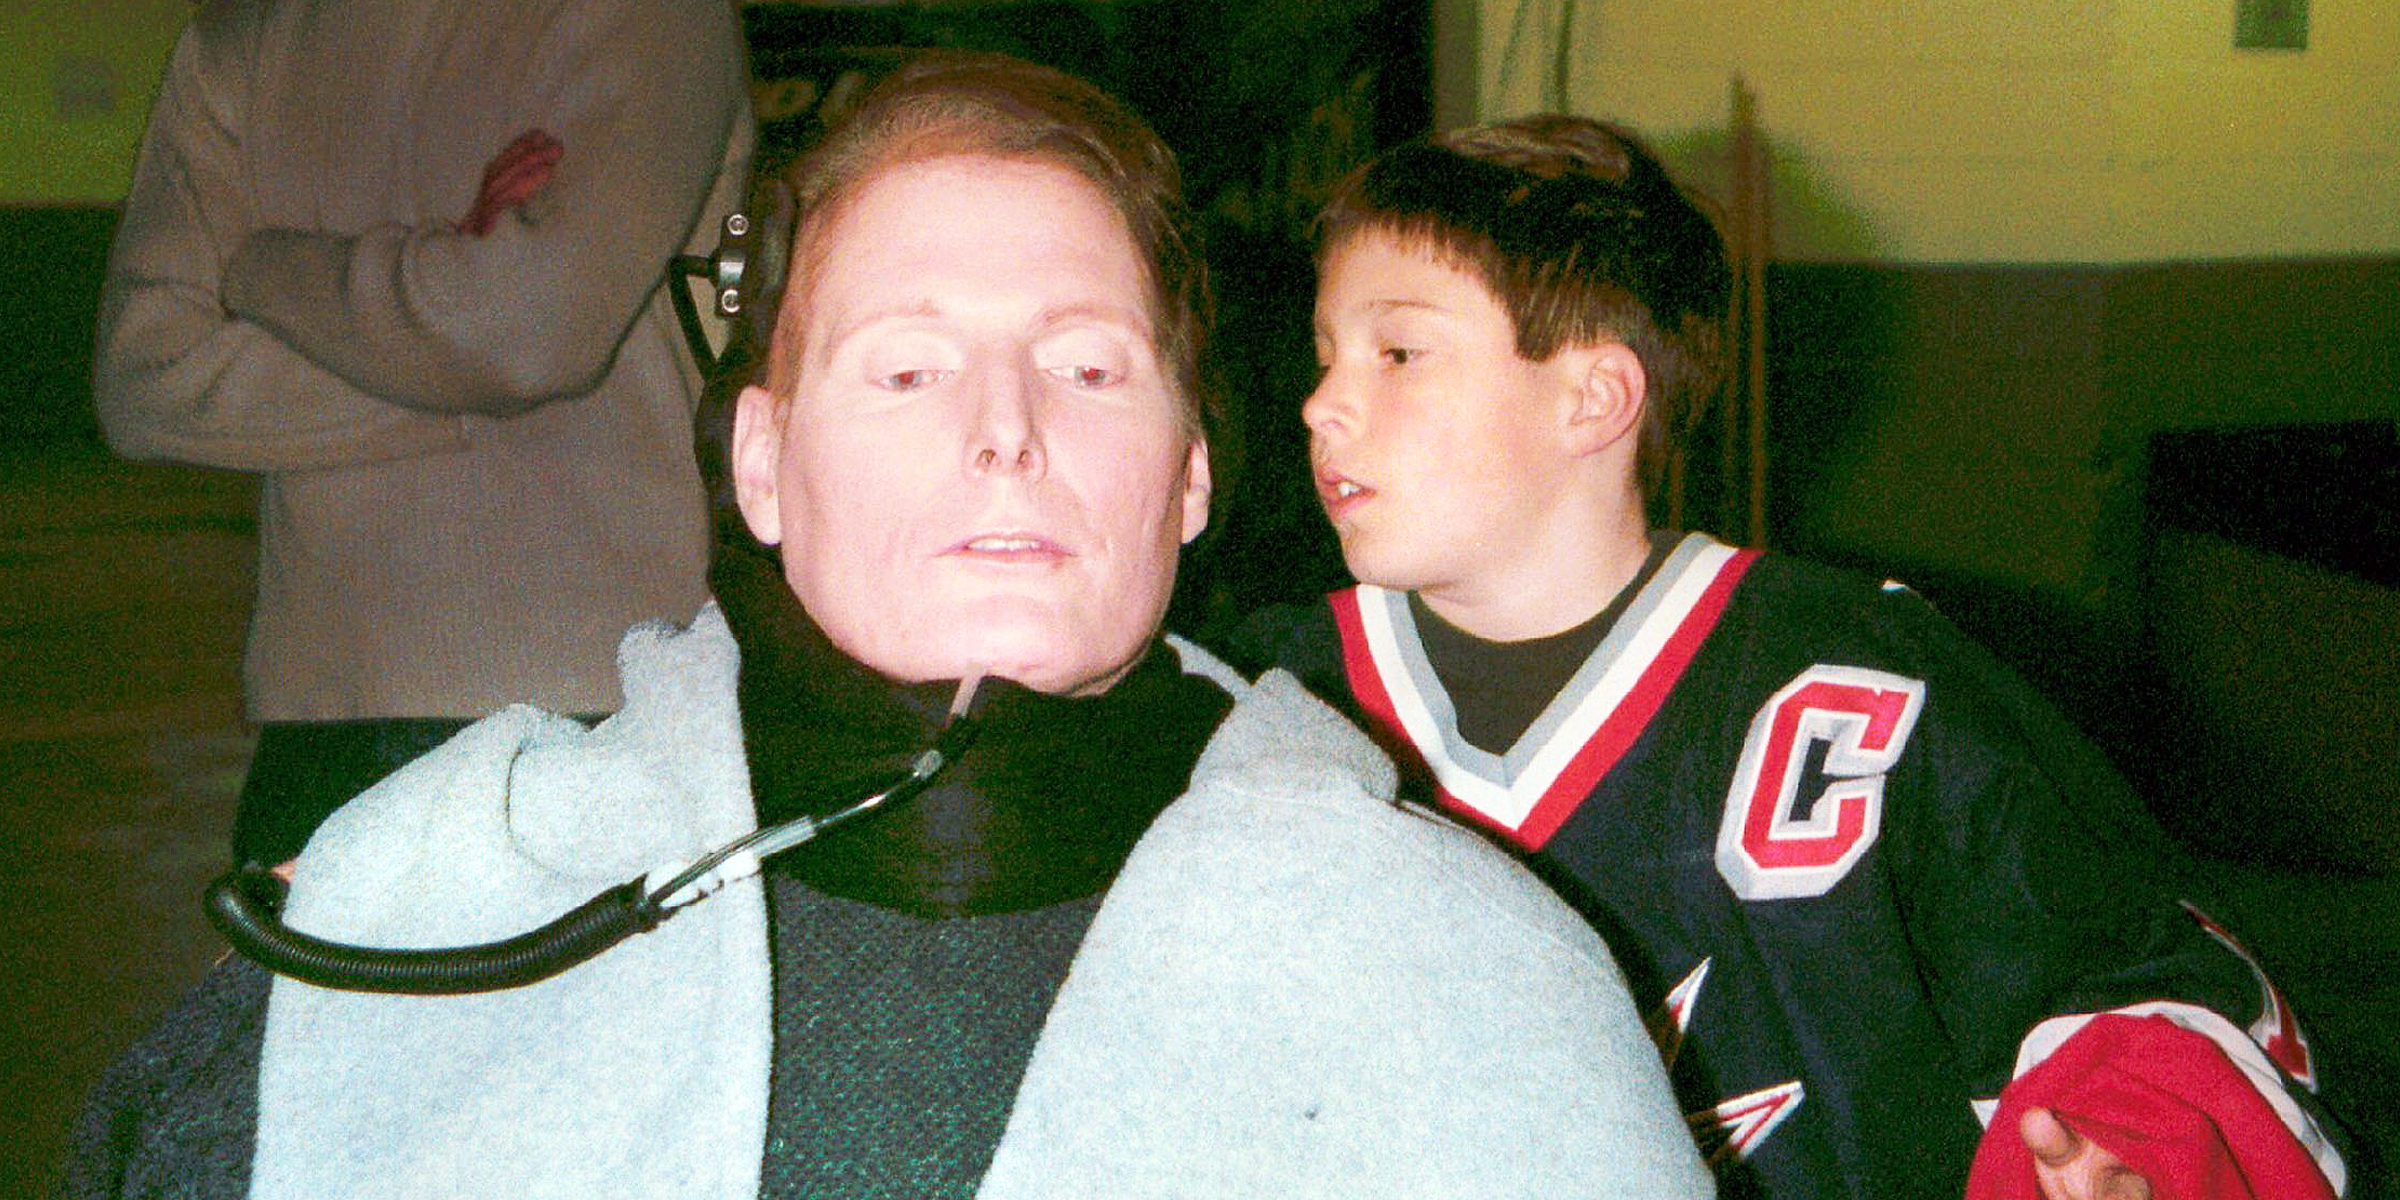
[{"left": 1966, "top": 1013, "right": 2333, "bottom": 1200}]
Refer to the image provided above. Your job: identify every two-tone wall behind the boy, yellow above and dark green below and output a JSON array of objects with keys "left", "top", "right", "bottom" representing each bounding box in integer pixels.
[{"left": 1457, "top": 0, "right": 2400, "bottom": 622}]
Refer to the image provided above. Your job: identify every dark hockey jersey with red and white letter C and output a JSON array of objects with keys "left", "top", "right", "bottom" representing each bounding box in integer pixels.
[{"left": 1277, "top": 535, "right": 2345, "bottom": 1200}]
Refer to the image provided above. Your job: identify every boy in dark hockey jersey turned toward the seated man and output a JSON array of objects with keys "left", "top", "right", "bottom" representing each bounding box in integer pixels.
[{"left": 1277, "top": 115, "right": 2345, "bottom": 1200}]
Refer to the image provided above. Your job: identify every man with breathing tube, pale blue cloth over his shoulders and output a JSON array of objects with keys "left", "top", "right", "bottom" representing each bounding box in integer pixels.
[{"left": 67, "top": 55, "right": 1711, "bottom": 1200}]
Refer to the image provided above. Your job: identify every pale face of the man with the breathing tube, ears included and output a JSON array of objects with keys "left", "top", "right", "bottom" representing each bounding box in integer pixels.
[{"left": 734, "top": 156, "right": 1210, "bottom": 694}]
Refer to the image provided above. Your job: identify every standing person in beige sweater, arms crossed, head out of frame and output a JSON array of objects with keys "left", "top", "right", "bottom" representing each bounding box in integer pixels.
[{"left": 94, "top": 0, "right": 751, "bottom": 864}]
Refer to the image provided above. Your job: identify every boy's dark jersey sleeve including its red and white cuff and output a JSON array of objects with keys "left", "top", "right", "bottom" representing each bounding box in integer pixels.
[{"left": 1891, "top": 612, "right": 2347, "bottom": 1195}]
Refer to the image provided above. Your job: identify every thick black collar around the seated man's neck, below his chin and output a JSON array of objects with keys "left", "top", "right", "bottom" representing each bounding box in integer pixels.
[{"left": 713, "top": 552, "right": 1231, "bottom": 917}]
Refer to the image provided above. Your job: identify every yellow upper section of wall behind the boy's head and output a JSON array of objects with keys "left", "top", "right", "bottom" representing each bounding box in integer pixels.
[{"left": 1474, "top": 0, "right": 2400, "bottom": 262}]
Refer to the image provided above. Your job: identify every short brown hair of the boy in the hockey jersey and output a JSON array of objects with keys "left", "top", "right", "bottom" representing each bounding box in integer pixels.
[{"left": 1318, "top": 113, "right": 1733, "bottom": 492}]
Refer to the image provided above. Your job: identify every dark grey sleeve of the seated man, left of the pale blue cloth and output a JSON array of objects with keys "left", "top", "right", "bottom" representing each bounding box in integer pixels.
[{"left": 58, "top": 960, "right": 269, "bottom": 1200}]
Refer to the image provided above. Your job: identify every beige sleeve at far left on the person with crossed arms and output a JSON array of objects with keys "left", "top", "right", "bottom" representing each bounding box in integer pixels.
[{"left": 94, "top": 15, "right": 466, "bottom": 470}]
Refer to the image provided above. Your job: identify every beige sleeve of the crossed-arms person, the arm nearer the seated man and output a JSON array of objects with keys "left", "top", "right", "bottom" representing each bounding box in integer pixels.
[{"left": 226, "top": 0, "right": 746, "bottom": 415}]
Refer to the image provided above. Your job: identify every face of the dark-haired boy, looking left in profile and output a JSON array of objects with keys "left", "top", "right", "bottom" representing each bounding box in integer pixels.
[{"left": 1301, "top": 233, "right": 1582, "bottom": 612}]
